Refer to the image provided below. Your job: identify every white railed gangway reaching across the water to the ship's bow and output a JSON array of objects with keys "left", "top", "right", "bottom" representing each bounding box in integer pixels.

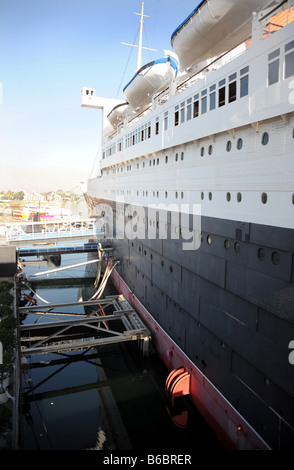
[{"left": 5, "top": 218, "right": 104, "bottom": 246}]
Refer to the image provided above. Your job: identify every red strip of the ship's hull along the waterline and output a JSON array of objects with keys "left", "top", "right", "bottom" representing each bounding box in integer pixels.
[{"left": 111, "top": 269, "right": 270, "bottom": 450}]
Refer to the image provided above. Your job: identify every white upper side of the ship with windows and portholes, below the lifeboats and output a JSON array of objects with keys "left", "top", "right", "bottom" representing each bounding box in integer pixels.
[{"left": 82, "top": 1, "right": 294, "bottom": 228}]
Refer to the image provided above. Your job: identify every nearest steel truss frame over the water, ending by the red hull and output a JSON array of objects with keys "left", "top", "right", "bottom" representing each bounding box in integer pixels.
[{"left": 19, "top": 295, "right": 151, "bottom": 356}]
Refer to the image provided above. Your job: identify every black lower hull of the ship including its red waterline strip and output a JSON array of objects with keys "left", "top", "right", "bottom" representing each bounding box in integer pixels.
[{"left": 87, "top": 193, "right": 294, "bottom": 449}]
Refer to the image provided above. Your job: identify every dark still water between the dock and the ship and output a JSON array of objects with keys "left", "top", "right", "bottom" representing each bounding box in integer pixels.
[{"left": 22, "top": 254, "right": 222, "bottom": 452}]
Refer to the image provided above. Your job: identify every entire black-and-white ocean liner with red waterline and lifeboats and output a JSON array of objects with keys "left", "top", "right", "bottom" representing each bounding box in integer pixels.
[{"left": 81, "top": 0, "right": 294, "bottom": 450}]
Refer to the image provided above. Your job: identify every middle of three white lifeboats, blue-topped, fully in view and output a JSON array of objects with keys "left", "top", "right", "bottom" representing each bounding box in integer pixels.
[{"left": 123, "top": 57, "right": 178, "bottom": 110}]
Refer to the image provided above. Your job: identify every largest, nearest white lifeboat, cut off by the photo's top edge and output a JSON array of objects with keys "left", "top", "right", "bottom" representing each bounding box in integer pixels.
[{"left": 171, "top": 0, "right": 272, "bottom": 71}]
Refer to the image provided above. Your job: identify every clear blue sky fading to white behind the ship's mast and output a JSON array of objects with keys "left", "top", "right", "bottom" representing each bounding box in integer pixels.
[{"left": 0, "top": 0, "right": 199, "bottom": 192}]
